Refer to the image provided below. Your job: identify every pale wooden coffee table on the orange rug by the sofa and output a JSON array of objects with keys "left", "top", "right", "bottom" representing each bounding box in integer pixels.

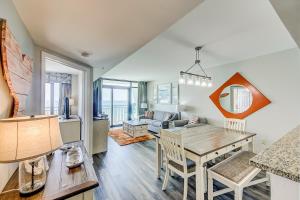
[{"left": 123, "top": 120, "right": 148, "bottom": 137}]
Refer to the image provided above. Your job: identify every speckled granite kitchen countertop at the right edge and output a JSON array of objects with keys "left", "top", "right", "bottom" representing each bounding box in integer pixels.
[{"left": 250, "top": 126, "right": 300, "bottom": 183}]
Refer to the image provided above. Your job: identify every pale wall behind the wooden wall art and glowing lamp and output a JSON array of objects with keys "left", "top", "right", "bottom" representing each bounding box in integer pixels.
[{"left": 0, "top": 0, "right": 36, "bottom": 192}]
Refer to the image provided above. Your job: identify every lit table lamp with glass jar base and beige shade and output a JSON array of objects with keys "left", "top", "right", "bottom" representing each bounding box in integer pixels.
[{"left": 0, "top": 115, "right": 63, "bottom": 196}]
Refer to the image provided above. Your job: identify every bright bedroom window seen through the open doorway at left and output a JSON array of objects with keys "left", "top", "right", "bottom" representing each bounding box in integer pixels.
[{"left": 45, "top": 83, "right": 60, "bottom": 115}]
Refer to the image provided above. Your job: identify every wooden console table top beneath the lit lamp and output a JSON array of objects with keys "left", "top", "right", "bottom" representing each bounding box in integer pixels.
[{"left": 0, "top": 141, "right": 99, "bottom": 200}]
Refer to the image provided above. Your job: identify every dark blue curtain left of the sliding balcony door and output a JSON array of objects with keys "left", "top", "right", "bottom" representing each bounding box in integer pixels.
[{"left": 93, "top": 78, "right": 102, "bottom": 116}]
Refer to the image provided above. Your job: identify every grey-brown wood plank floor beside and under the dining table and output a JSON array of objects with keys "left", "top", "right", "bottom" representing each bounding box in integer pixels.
[{"left": 93, "top": 138, "right": 270, "bottom": 200}]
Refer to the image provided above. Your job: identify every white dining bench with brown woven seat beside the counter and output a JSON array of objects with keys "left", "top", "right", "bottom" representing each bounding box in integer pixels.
[{"left": 207, "top": 151, "right": 269, "bottom": 200}]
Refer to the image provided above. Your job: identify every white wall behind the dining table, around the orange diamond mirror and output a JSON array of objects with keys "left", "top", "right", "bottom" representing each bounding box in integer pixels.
[{"left": 148, "top": 48, "right": 300, "bottom": 151}]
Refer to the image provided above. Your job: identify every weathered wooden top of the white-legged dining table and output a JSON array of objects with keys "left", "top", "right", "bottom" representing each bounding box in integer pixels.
[{"left": 155, "top": 125, "right": 256, "bottom": 156}]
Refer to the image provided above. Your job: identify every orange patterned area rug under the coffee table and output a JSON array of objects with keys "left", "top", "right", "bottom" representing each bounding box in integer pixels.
[{"left": 108, "top": 129, "right": 154, "bottom": 146}]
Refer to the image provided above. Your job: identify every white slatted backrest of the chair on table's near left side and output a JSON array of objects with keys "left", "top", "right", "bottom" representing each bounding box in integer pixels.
[{"left": 160, "top": 129, "right": 187, "bottom": 172}]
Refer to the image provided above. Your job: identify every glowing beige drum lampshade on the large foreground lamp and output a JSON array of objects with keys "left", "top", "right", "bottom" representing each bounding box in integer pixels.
[{"left": 0, "top": 115, "right": 63, "bottom": 163}]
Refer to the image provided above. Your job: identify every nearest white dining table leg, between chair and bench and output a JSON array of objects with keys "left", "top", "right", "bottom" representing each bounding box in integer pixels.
[{"left": 196, "top": 161, "right": 205, "bottom": 200}]
